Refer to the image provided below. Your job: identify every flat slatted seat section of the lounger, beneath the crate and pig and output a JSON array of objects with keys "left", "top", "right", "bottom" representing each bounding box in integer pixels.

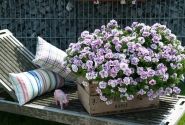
[{"left": 0, "top": 86, "right": 185, "bottom": 125}]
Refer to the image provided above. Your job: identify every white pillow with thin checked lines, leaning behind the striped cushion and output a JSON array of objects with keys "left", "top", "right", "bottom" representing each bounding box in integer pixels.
[{"left": 33, "top": 37, "right": 75, "bottom": 80}]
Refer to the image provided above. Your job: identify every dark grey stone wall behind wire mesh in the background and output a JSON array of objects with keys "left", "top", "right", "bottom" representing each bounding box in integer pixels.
[{"left": 0, "top": 0, "right": 185, "bottom": 53}]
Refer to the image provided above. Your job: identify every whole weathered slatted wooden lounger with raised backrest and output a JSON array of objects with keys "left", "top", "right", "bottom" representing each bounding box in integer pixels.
[{"left": 0, "top": 30, "right": 185, "bottom": 125}]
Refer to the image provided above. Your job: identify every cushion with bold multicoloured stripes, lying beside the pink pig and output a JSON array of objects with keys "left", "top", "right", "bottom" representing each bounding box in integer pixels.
[{"left": 10, "top": 69, "right": 64, "bottom": 105}]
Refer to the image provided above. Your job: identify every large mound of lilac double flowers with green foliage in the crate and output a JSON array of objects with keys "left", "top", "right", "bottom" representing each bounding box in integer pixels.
[{"left": 66, "top": 20, "right": 185, "bottom": 104}]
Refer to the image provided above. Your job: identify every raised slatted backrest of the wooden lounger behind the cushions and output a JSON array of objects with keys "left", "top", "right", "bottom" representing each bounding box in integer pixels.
[{"left": 0, "top": 30, "right": 37, "bottom": 100}]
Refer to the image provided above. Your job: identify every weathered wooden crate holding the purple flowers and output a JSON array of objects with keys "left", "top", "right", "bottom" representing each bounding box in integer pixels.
[{"left": 77, "top": 84, "right": 159, "bottom": 116}]
